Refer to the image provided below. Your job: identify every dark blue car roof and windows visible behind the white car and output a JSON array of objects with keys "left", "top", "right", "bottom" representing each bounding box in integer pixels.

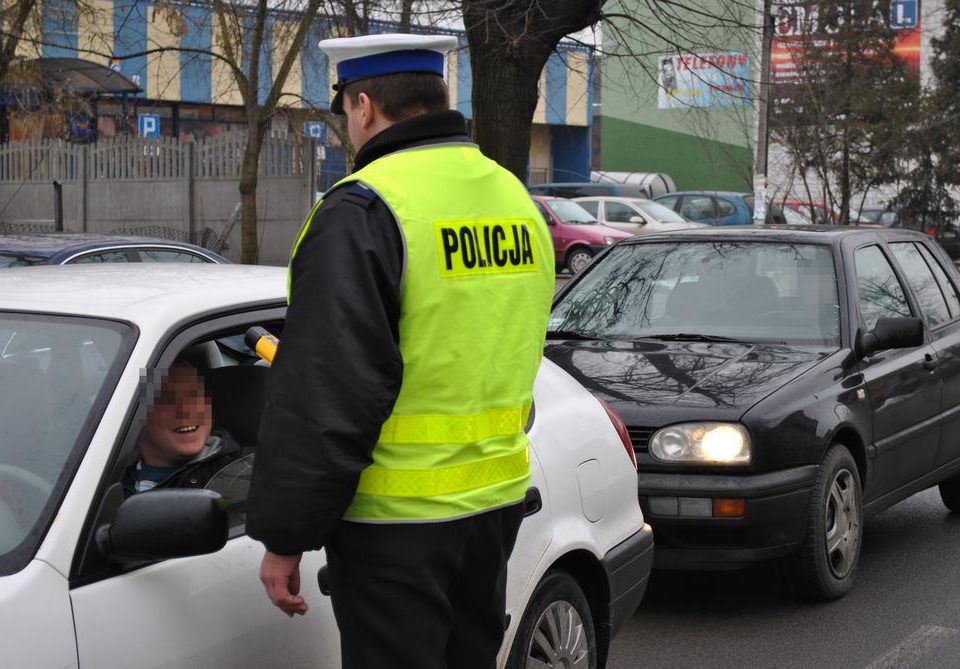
[{"left": 0, "top": 232, "right": 230, "bottom": 268}]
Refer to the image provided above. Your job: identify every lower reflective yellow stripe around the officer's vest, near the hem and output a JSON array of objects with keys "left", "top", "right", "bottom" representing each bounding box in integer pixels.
[{"left": 357, "top": 448, "right": 530, "bottom": 497}]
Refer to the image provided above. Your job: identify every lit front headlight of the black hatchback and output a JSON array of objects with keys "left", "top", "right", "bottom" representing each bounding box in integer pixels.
[{"left": 649, "top": 422, "right": 750, "bottom": 465}]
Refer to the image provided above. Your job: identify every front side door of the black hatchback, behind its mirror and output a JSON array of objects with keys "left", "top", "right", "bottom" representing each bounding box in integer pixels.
[{"left": 854, "top": 244, "right": 941, "bottom": 500}]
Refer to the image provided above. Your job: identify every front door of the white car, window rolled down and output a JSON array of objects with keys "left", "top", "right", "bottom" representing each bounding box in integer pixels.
[{"left": 70, "top": 309, "right": 340, "bottom": 669}]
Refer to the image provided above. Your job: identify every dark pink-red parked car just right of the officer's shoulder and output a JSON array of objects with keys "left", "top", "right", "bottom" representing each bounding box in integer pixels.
[{"left": 532, "top": 195, "right": 630, "bottom": 274}]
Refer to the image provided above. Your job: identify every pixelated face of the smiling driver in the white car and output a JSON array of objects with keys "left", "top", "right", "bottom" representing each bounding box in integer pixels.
[{"left": 137, "top": 361, "right": 213, "bottom": 467}]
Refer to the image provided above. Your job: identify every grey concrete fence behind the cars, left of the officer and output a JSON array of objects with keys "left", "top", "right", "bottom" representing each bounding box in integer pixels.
[{"left": 0, "top": 134, "right": 316, "bottom": 265}]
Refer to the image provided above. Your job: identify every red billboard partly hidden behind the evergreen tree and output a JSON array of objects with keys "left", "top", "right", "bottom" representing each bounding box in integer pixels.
[{"left": 770, "top": 0, "right": 921, "bottom": 85}]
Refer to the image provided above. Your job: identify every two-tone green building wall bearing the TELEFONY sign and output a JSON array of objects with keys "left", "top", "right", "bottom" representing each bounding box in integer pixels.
[{"left": 595, "top": 0, "right": 759, "bottom": 191}]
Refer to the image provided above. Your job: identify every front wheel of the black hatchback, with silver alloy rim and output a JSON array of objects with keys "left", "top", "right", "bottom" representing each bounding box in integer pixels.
[{"left": 787, "top": 444, "right": 863, "bottom": 601}]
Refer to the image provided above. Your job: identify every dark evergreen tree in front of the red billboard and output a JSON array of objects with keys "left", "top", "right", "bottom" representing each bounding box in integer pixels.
[{"left": 771, "top": 0, "right": 919, "bottom": 224}]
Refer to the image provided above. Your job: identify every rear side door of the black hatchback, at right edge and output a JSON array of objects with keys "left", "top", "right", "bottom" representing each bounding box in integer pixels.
[{"left": 888, "top": 241, "right": 960, "bottom": 468}]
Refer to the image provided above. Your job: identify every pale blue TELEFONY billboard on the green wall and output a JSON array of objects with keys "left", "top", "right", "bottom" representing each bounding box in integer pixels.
[{"left": 657, "top": 51, "right": 750, "bottom": 109}]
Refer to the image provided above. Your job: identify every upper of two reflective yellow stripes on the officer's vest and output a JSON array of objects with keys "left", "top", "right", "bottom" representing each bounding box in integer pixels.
[{"left": 380, "top": 404, "right": 530, "bottom": 444}]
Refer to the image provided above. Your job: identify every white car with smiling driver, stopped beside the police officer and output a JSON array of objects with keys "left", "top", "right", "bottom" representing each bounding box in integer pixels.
[{"left": 0, "top": 264, "right": 653, "bottom": 669}]
